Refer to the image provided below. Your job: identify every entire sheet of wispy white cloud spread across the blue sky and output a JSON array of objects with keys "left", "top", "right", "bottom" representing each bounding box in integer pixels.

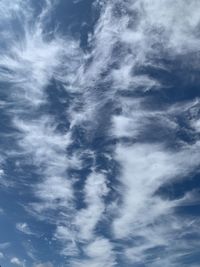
[{"left": 0, "top": 0, "right": 200, "bottom": 267}]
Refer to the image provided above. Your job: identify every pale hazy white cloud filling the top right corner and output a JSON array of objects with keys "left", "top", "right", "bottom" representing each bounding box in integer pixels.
[{"left": 137, "top": 0, "right": 200, "bottom": 53}]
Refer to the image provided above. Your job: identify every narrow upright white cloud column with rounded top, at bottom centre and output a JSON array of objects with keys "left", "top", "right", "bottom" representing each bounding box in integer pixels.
[{"left": 55, "top": 171, "right": 109, "bottom": 256}]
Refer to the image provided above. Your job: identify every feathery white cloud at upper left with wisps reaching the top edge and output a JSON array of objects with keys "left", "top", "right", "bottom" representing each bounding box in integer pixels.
[{"left": 0, "top": 0, "right": 82, "bottom": 108}]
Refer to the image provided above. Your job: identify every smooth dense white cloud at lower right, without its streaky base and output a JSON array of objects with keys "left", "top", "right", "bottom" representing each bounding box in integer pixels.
[{"left": 115, "top": 143, "right": 199, "bottom": 236}]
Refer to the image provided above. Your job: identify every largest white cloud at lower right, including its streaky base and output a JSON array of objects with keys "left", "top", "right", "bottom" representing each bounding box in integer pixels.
[{"left": 113, "top": 143, "right": 199, "bottom": 262}]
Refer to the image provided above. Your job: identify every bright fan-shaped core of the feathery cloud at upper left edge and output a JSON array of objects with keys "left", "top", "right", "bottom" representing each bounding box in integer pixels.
[{"left": 0, "top": 25, "right": 81, "bottom": 107}]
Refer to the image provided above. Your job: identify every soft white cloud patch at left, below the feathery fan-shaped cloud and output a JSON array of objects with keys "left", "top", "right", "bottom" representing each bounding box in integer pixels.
[{"left": 15, "top": 117, "right": 78, "bottom": 211}]
